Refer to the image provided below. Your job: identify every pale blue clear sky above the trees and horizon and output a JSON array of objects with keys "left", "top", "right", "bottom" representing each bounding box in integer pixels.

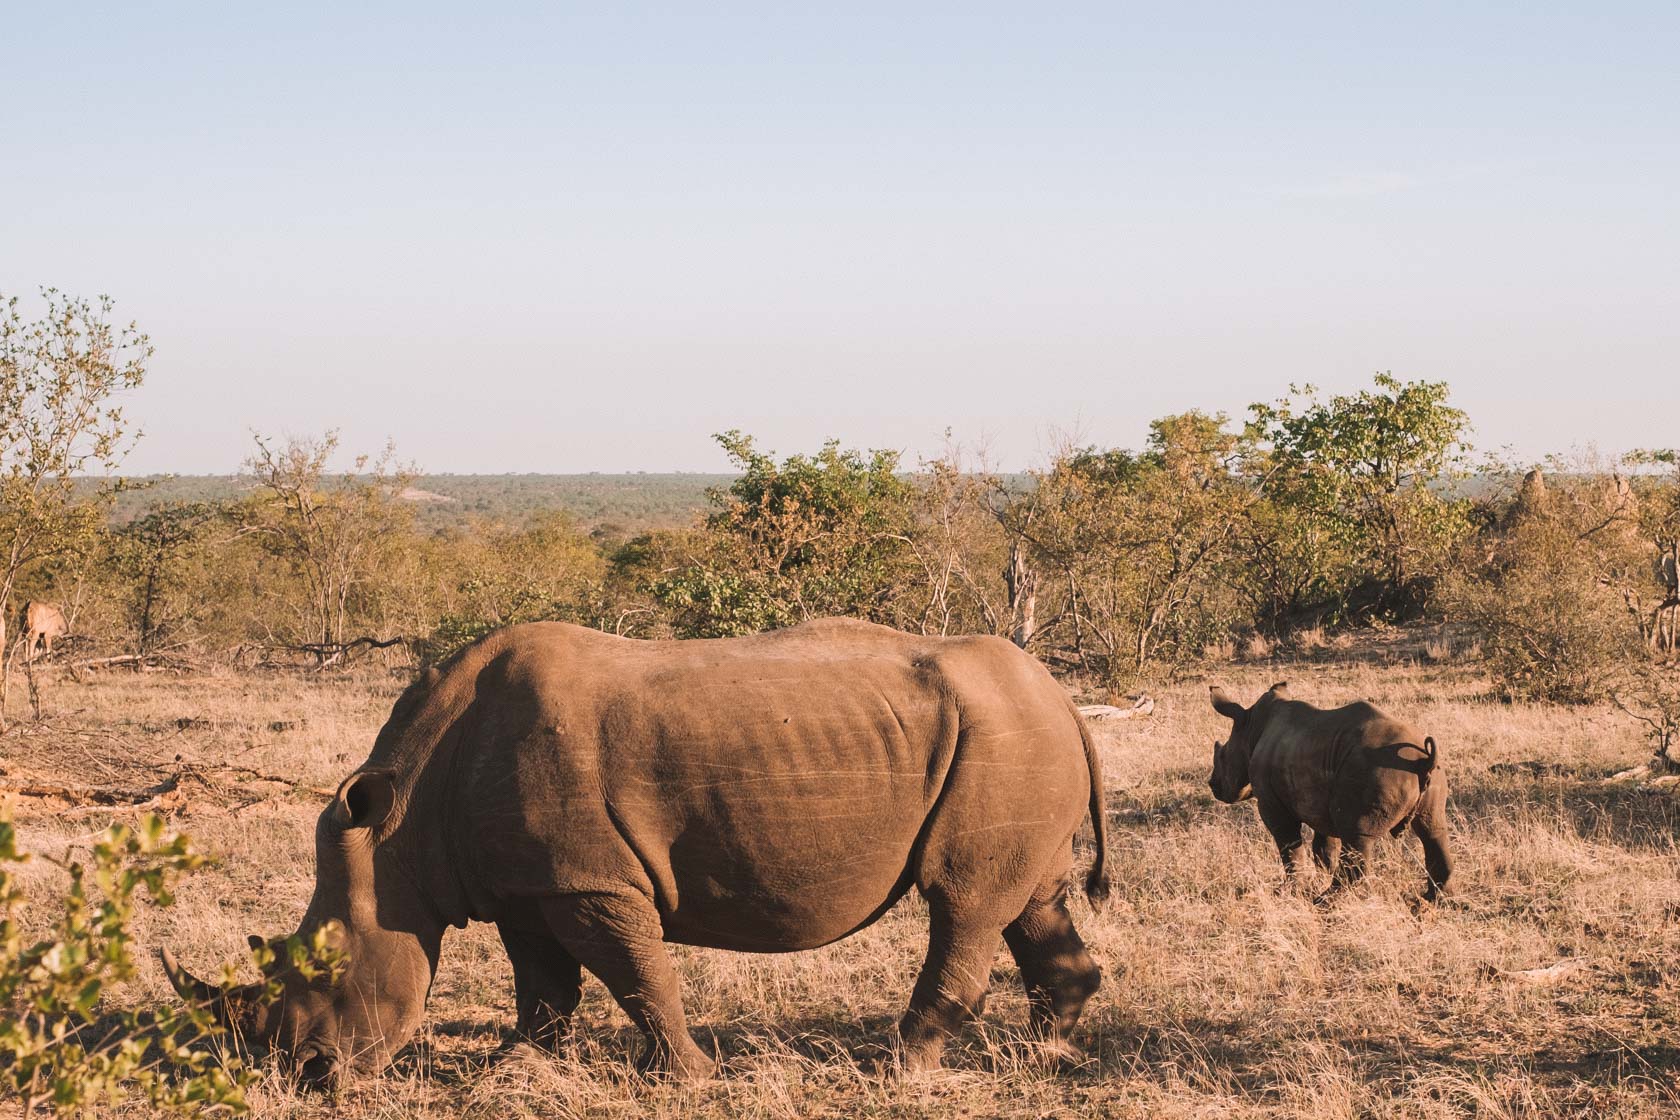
[{"left": 0, "top": 0, "right": 1680, "bottom": 472}]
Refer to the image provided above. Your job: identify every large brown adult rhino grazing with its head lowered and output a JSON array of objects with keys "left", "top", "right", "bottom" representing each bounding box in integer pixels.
[{"left": 165, "top": 620, "right": 1107, "bottom": 1081}]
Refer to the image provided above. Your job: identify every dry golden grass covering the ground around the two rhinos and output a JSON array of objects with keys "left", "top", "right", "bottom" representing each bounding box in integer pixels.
[{"left": 0, "top": 657, "right": 1680, "bottom": 1120}]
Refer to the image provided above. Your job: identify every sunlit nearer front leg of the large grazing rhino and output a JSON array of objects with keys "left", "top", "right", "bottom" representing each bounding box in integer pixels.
[{"left": 543, "top": 895, "right": 716, "bottom": 1081}]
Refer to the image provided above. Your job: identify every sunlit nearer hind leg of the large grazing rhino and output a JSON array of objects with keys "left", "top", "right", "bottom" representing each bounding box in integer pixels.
[{"left": 899, "top": 892, "right": 1000, "bottom": 1073}]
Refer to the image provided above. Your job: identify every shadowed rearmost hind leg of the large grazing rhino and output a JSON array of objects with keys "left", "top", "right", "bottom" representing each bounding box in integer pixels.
[{"left": 1003, "top": 877, "right": 1102, "bottom": 1056}]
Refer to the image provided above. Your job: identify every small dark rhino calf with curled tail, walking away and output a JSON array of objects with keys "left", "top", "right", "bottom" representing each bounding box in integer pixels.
[{"left": 1208, "top": 683, "right": 1453, "bottom": 903}]
